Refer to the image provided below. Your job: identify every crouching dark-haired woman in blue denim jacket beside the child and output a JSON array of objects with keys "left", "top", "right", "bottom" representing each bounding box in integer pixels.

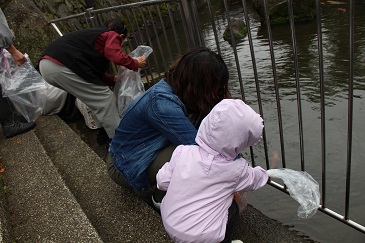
[{"left": 107, "top": 48, "right": 230, "bottom": 201}]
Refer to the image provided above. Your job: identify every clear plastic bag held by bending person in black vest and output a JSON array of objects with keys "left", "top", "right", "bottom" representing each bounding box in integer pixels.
[{"left": 114, "top": 45, "right": 153, "bottom": 116}]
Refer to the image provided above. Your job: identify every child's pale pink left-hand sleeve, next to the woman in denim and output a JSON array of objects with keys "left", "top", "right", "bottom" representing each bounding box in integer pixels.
[{"left": 156, "top": 145, "right": 182, "bottom": 191}]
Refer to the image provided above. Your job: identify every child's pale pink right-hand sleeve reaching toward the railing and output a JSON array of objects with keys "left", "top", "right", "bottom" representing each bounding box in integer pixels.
[{"left": 236, "top": 161, "right": 269, "bottom": 191}]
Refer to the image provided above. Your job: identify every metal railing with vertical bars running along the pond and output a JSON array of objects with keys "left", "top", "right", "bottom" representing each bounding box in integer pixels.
[{"left": 49, "top": 0, "right": 365, "bottom": 233}]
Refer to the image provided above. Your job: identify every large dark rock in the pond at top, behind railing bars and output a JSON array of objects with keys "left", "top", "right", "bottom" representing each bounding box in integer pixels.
[{"left": 253, "top": 0, "right": 316, "bottom": 25}]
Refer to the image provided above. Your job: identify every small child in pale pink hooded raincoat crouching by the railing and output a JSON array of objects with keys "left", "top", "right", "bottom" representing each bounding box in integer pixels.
[{"left": 156, "top": 99, "right": 268, "bottom": 242}]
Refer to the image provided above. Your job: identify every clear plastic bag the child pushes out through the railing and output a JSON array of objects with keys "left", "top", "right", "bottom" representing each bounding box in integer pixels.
[{"left": 267, "top": 168, "right": 321, "bottom": 218}]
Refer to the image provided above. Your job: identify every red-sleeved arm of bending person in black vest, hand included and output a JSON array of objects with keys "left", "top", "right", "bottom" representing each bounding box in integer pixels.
[{"left": 104, "top": 31, "right": 146, "bottom": 71}]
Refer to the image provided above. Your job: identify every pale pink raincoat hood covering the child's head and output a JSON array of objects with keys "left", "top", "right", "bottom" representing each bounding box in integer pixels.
[{"left": 195, "top": 99, "right": 264, "bottom": 160}]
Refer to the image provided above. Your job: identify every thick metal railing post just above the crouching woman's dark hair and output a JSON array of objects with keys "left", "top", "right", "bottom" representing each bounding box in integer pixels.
[{"left": 181, "top": 0, "right": 204, "bottom": 47}]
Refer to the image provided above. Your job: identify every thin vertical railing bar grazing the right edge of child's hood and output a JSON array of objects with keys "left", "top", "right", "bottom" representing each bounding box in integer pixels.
[{"left": 242, "top": 0, "right": 270, "bottom": 169}]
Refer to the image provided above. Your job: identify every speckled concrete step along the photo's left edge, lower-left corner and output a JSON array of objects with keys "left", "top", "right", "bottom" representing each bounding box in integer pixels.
[{"left": 0, "top": 119, "right": 102, "bottom": 242}]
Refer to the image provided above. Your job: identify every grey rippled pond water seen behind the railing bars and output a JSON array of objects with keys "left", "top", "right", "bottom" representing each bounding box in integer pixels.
[{"left": 195, "top": 0, "right": 365, "bottom": 242}]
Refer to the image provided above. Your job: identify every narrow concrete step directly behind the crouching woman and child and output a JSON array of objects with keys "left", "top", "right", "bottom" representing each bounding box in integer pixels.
[{"left": 35, "top": 116, "right": 169, "bottom": 242}]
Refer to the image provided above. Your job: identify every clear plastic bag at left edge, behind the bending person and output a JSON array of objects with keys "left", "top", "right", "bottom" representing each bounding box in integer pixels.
[{"left": 0, "top": 50, "right": 47, "bottom": 121}]
